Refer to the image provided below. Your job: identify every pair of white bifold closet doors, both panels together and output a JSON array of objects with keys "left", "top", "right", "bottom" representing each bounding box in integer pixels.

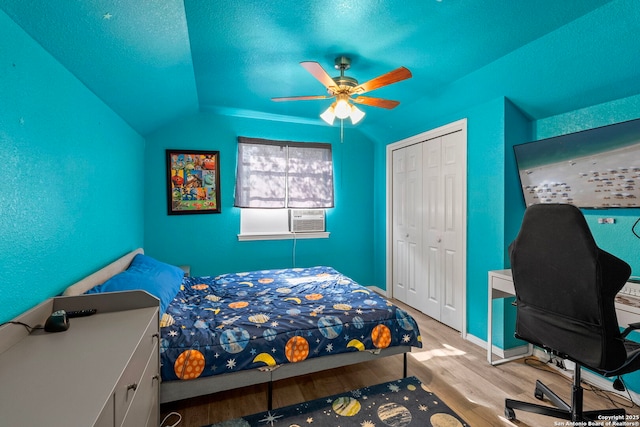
[{"left": 386, "top": 119, "right": 467, "bottom": 336}]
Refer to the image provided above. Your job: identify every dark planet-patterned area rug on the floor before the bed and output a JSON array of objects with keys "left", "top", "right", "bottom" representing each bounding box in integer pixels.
[{"left": 206, "top": 377, "right": 468, "bottom": 427}]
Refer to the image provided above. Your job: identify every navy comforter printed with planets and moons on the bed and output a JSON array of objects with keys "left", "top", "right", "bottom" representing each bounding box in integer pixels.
[{"left": 160, "top": 267, "right": 422, "bottom": 381}]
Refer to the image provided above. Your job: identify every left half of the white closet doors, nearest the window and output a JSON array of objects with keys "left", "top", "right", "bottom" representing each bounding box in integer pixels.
[{"left": 392, "top": 144, "right": 423, "bottom": 306}]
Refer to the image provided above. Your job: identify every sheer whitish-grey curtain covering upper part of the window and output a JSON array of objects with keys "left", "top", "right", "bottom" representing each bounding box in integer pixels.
[{"left": 235, "top": 137, "right": 333, "bottom": 208}]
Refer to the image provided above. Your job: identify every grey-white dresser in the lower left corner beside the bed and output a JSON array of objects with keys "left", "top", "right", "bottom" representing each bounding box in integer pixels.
[{"left": 0, "top": 291, "right": 160, "bottom": 427}]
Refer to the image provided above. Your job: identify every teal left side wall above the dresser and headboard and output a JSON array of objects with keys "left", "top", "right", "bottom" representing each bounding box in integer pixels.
[{"left": 0, "top": 11, "right": 144, "bottom": 322}]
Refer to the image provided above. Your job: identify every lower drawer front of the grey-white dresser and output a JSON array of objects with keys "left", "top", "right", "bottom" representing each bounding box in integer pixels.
[{"left": 122, "top": 352, "right": 160, "bottom": 427}]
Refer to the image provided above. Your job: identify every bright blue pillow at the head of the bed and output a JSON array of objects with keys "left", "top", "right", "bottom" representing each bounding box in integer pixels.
[{"left": 86, "top": 254, "right": 184, "bottom": 314}]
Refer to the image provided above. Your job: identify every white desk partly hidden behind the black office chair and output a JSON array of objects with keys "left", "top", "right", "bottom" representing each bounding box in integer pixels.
[{"left": 487, "top": 270, "right": 640, "bottom": 365}]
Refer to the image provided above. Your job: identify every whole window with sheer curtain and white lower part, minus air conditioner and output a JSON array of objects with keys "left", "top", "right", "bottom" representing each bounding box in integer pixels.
[{"left": 235, "top": 137, "right": 334, "bottom": 240}]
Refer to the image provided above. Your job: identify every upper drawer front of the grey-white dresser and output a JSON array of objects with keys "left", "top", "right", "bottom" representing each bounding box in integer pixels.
[{"left": 114, "top": 318, "right": 158, "bottom": 426}]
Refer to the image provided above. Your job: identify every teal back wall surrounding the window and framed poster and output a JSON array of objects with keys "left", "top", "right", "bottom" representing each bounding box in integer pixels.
[{"left": 145, "top": 112, "right": 384, "bottom": 286}]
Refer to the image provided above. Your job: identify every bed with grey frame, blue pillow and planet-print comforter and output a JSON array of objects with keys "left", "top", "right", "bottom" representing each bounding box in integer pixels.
[{"left": 64, "top": 249, "right": 422, "bottom": 408}]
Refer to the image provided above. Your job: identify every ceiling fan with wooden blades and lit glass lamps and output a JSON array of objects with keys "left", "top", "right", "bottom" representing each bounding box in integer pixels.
[{"left": 271, "top": 56, "right": 411, "bottom": 125}]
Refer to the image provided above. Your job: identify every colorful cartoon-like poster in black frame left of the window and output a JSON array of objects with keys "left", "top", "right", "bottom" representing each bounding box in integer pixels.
[{"left": 166, "top": 149, "right": 221, "bottom": 215}]
